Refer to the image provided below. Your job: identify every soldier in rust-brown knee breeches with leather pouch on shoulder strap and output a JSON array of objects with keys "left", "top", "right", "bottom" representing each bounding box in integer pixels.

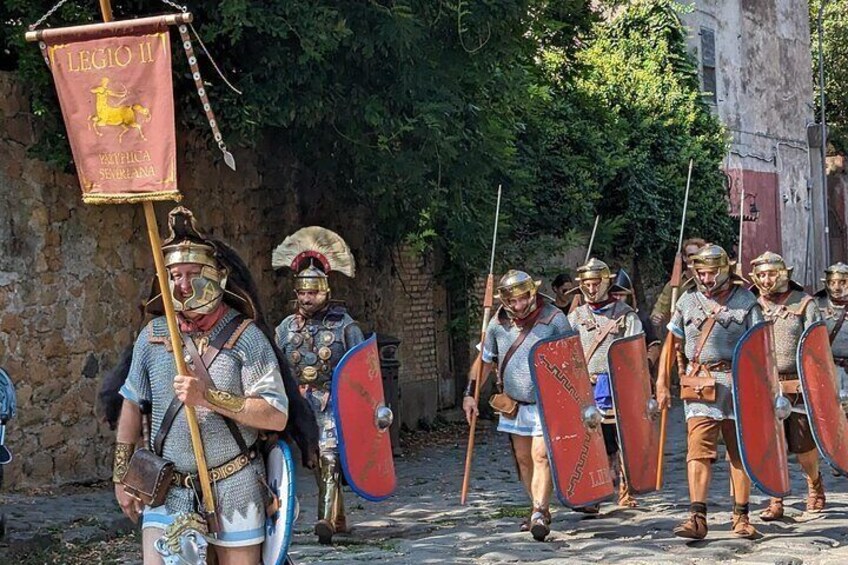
[{"left": 656, "top": 245, "right": 763, "bottom": 539}]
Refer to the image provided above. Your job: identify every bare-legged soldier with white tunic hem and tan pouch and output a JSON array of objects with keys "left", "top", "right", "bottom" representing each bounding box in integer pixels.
[{"left": 462, "top": 270, "right": 571, "bottom": 541}]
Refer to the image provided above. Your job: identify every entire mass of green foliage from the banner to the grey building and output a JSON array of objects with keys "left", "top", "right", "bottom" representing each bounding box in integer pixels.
[{"left": 0, "top": 0, "right": 732, "bottom": 312}]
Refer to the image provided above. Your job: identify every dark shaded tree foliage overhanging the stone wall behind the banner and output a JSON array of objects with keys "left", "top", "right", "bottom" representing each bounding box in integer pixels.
[{"left": 0, "top": 0, "right": 592, "bottom": 265}]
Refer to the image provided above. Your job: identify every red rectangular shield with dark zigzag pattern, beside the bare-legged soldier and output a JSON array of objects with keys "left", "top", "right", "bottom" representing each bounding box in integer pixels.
[{"left": 530, "top": 333, "right": 614, "bottom": 508}]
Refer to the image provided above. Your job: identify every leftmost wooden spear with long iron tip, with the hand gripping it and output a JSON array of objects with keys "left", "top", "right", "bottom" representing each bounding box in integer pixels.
[{"left": 460, "top": 186, "right": 501, "bottom": 504}]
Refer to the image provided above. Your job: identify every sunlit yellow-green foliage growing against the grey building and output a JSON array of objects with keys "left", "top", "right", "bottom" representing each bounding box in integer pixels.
[{"left": 577, "top": 0, "right": 733, "bottom": 280}]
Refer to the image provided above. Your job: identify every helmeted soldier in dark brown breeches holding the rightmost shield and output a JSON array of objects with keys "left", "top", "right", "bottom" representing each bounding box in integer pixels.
[{"left": 749, "top": 251, "right": 825, "bottom": 522}]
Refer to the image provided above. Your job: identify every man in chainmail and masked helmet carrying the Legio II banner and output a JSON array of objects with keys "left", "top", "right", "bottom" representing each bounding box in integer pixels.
[{"left": 113, "top": 207, "right": 289, "bottom": 563}]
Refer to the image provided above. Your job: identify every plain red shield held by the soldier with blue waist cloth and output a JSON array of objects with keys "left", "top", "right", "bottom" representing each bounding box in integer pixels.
[{"left": 607, "top": 333, "right": 660, "bottom": 494}]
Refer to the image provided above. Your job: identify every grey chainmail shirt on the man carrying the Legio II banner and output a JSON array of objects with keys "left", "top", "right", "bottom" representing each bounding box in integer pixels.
[{"left": 121, "top": 309, "right": 288, "bottom": 528}]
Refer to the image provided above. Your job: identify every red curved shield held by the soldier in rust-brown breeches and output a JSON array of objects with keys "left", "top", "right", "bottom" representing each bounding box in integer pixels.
[{"left": 733, "top": 322, "right": 790, "bottom": 498}]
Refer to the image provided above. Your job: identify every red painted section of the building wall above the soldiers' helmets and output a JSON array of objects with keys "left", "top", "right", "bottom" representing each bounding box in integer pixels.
[{"left": 725, "top": 169, "right": 783, "bottom": 266}]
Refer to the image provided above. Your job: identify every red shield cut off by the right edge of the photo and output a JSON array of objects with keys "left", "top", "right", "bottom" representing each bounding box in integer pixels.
[{"left": 797, "top": 322, "right": 848, "bottom": 475}]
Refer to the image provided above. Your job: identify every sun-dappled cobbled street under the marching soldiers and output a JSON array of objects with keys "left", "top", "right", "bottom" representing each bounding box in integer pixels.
[{"left": 0, "top": 410, "right": 848, "bottom": 565}]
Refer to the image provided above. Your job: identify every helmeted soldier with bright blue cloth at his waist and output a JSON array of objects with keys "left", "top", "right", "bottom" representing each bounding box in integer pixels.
[{"left": 568, "top": 257, "right": 643, "bottom": 506}]
